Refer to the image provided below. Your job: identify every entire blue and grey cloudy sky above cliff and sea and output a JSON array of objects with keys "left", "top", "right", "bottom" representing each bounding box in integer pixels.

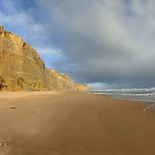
[{"left": 0, "top": 0, "right": 155, "bottom": 89}]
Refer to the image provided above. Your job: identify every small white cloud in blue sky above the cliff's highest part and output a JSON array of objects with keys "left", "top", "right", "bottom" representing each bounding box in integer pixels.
[{"left": 0, "top": 0, "right": 45, "bottom": 35}]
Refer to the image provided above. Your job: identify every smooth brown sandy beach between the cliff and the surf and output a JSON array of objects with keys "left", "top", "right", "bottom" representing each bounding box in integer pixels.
[{"left": 0, "top": 92, "right": 155, "bottom": 155}]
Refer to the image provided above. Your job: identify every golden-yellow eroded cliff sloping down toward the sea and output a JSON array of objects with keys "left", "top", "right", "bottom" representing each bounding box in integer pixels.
[{"left": 0, "top": 26, "right": 88, "bottom": 91}]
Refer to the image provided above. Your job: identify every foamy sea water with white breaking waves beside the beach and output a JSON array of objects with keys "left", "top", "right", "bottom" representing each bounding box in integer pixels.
[{"left": 90, "top": 87, "right": 155, "bottom": 107}]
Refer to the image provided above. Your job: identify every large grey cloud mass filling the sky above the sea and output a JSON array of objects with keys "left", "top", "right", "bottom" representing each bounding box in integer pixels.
[{"left": 34, "top": 0, "right": 155, "bottom": 85}]
